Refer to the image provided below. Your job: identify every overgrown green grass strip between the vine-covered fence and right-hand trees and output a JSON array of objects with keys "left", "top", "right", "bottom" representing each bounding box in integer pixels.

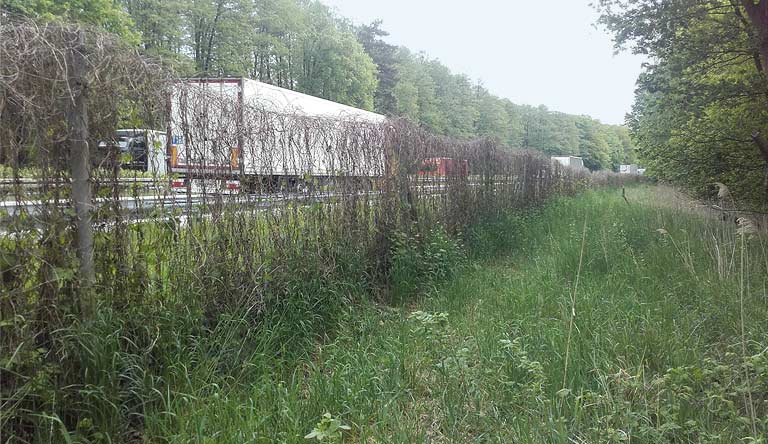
[{"left": 144, "top": 187, "right": 768, "bottom": 443}]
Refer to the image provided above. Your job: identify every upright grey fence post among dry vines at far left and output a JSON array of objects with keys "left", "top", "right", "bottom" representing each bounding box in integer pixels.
[{"left": 67, "top": 30, "right": 96, "bottom": 311}]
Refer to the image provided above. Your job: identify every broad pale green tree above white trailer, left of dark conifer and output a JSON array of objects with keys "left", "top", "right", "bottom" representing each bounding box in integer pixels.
[{"left": 244, "top": 0, "right": 376, "bottom": 109}]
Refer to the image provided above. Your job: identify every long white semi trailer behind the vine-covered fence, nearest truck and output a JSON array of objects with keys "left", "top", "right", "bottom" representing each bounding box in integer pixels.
[{"left": 167, "top": 78, "right": 386, "bottom": 193}]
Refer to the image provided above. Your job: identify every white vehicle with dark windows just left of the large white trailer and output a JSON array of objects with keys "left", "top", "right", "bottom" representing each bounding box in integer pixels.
[{"left": 99, "top": 129, "right": 168, "bottom": 176}]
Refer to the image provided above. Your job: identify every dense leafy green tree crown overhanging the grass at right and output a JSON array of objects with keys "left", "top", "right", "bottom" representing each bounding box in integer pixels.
[{"left": 598, "top": 0, "right": 768, "bottom": 207}]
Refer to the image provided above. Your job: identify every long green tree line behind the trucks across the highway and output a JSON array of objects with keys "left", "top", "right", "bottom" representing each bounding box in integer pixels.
[{"left": 0, "top": 0, "right": 636, "bottom": 170}]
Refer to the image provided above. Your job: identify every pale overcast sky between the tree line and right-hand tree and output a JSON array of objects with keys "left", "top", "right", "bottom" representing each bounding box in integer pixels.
[{"left": 321, "top": 0, "right": 643, "bottom": 124}]
